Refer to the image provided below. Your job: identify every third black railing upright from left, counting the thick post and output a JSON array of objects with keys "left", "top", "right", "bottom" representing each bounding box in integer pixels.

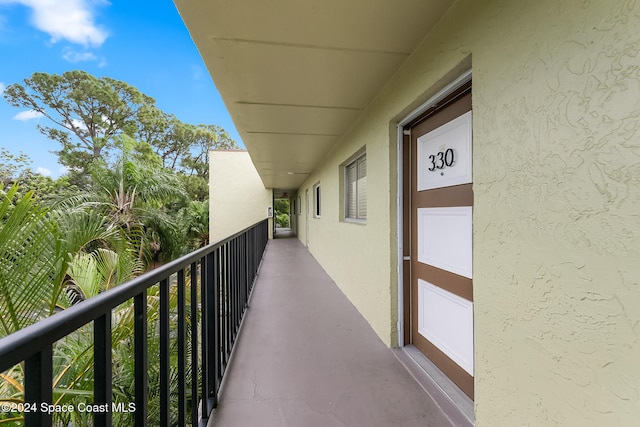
[{"left": 133, "top": 289, "right": 149, "bottom": 427}]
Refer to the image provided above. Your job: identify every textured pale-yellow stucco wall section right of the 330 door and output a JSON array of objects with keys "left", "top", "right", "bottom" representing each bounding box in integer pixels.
[{"left": 473, "top": 1, "right": 640, "bottom": 426}]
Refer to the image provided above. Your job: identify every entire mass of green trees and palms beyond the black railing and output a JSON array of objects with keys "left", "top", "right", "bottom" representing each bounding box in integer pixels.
[{"left": 0, "top": 71, "right": 236, "bottom": 425}]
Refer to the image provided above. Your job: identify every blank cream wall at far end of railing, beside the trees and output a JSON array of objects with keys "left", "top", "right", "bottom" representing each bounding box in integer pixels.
[{"left": 209, "top": 150, "right": 273, "bottom": 242}]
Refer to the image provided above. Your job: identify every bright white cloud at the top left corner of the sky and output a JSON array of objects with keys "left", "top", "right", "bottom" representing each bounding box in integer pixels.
[{"left": 0, "top": 0, "right": 108, "bottom": 47}]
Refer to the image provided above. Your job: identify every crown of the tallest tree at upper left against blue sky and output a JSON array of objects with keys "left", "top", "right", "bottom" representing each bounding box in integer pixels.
[{"left": 4, "top": 70, "right": 155, "bottom": 182}]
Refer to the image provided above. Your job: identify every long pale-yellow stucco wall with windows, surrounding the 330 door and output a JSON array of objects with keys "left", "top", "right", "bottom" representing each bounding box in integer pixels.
[{"left": 299, "top": 0, "right": 640, "bottom": 427}]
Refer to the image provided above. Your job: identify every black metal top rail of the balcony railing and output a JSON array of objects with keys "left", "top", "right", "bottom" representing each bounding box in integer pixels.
[{"left": 0, "top": 219, "right": 266, "bottom": 372}]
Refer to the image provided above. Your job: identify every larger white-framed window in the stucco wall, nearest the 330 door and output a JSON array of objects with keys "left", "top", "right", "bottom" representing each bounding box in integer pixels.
[{"left": 344, "top": 154, "right": 367, "bottom": 221}]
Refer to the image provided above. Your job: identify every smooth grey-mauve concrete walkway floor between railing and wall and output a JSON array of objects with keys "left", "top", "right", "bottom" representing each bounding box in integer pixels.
[{"left": 209, "top": 238, "right": 460, "bottom": 427}]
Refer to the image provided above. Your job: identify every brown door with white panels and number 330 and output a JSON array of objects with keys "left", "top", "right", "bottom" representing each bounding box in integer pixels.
[{"left": 405, "top": 82, "right": 474, "bottom": 399}]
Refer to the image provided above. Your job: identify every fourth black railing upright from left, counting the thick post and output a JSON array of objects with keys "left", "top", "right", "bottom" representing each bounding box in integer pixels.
[{"left": 159, "top": 279, "right": 171, "bottom": 427}]
